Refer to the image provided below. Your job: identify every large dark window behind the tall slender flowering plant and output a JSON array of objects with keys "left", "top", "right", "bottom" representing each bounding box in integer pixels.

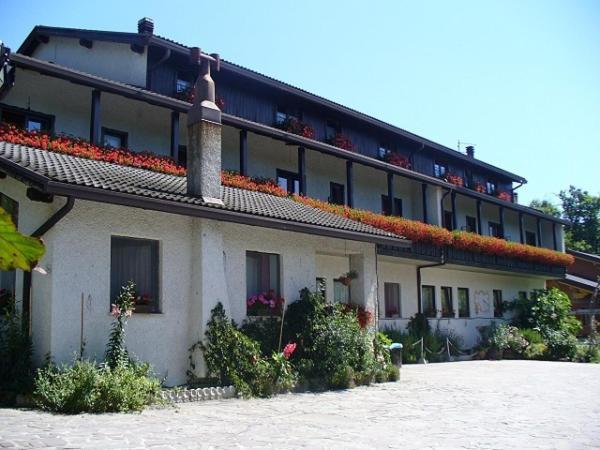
[{"left": 110, "top": 236, "right": 159, "bottom": 313}]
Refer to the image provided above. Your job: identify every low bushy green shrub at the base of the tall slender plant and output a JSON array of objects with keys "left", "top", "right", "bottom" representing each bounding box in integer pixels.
[{"left": 34, "top": 361, "right": 160, "bottom": 414}]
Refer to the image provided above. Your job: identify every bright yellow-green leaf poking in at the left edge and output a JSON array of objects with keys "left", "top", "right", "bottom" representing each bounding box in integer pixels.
[{"left": 0, "top": 208, "right": 46, "bottom": 271}]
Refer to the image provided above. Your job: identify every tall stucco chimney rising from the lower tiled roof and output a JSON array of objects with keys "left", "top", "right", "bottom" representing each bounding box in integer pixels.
[{"left": 187, "top": 47, "right": 223, "bottom": 205}]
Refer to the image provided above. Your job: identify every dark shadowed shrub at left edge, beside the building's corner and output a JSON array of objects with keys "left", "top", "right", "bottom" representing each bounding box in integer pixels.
[{"left": 0, "top": 300, "right": 33, "bottom": 393}]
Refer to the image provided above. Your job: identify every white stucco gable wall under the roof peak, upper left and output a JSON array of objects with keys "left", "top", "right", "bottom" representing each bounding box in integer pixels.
[{"left": 32, "top": 36, "right": 147, "bottom": 87}]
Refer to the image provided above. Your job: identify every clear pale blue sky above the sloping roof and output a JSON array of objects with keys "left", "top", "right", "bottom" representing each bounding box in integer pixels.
[{"left": 0, "top": 0, "right": 600, "bottom": 203}]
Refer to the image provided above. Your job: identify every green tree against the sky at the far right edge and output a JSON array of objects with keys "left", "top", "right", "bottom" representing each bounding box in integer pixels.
[{"left": 558, "top": 186, "right": 600, "bottom": 254}]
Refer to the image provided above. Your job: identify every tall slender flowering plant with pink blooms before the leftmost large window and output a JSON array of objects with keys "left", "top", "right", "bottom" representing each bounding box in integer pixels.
[{"left": 104, "top": 281, "right": 135, "bottom": 368}]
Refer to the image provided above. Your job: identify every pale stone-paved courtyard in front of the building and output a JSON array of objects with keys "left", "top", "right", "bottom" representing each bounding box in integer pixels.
[{"left": 0, "top": 361, "right": 600, "bottom": 449}]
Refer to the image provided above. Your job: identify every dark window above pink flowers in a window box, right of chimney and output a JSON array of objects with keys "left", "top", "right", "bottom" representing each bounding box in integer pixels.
[{"left": 246, "top": 252, "right": 280, "bottom": 298}]
